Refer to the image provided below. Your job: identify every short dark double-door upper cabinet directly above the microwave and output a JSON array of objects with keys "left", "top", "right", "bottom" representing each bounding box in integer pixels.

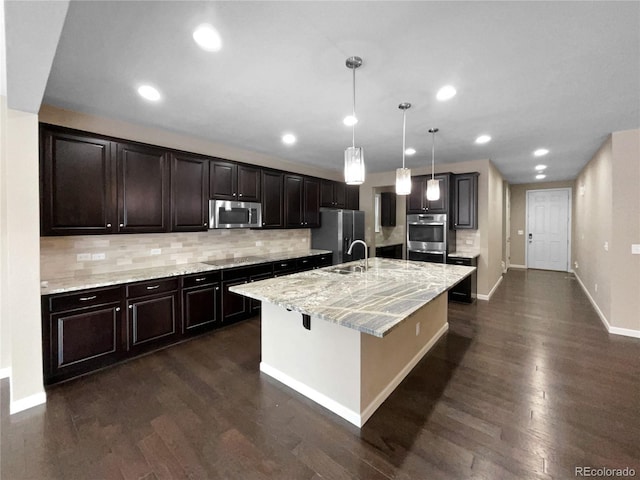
[{"left": 209, "top": 160, "right": 261, "bottom": 202}]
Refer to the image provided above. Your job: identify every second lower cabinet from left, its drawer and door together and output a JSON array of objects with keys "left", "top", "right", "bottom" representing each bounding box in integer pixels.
[{"left": 127, "top": 278, "right": 180, "bottom": 352}]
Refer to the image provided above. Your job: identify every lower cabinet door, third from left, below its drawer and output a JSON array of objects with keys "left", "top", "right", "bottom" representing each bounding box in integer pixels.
[{"left": 182, "top": 283, "right": 221, "bottom": 334}]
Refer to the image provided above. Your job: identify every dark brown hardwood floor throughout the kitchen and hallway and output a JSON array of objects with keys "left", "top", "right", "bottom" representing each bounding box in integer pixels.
[{"left": 0, "top": 270, "right": 640, "bottom": 480}]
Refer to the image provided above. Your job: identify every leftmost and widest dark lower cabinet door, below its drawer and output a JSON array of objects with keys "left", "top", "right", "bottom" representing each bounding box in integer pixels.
[{"left": 44, "top": 302, "right": 122, "bottom": 383}]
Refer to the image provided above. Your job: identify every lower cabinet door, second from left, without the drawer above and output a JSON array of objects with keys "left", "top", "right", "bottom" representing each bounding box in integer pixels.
[{"left": 127, "top": 291, "right": 179, "bottom": 353}]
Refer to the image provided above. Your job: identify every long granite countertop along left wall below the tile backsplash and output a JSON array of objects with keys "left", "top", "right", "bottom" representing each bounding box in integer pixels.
[{"left": 40, "top": 249, "right": 332, "bottom": 295}]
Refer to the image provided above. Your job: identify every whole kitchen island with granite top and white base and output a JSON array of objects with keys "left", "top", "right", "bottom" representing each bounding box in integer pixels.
[{"left": 231, "top": 258, "right": 475, "bottom": 427}]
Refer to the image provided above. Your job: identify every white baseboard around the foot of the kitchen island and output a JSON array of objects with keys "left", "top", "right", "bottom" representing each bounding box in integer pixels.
[{"left": 260, "top": 323, "right": 449, "bottom": 428}]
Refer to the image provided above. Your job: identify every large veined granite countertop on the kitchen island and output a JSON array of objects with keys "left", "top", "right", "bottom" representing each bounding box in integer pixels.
[{"left": 230, "top": 257, "right": 475, "bottom": 337}]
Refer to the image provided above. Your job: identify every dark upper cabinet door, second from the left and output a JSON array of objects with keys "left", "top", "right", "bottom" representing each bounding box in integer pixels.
[{"left": 117, "top": 143, "right": 170, "bottom": 233}]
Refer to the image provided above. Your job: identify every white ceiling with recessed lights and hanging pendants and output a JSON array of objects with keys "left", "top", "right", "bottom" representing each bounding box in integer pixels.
[{"left": 8, "top": 1, "right": 640, "bottom": 183}]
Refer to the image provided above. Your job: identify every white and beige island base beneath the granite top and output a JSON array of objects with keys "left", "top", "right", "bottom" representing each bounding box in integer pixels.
[{"left": 260, "top": 291, "right": 449, "bottom": 427}]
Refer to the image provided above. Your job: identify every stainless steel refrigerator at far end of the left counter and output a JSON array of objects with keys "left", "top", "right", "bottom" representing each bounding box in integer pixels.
[{"left": 311, "top": 208, "right": 364, "bottom": 265}]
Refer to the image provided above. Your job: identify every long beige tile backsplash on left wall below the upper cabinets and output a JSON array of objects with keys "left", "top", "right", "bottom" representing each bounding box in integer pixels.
[{"left": 40, "top": 229, "right": 311, "bottom": 280}]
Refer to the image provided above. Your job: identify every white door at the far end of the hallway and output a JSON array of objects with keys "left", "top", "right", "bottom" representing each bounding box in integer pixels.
[{"left": 526, "top": 188, "right": 571, "bottom": 271}]
